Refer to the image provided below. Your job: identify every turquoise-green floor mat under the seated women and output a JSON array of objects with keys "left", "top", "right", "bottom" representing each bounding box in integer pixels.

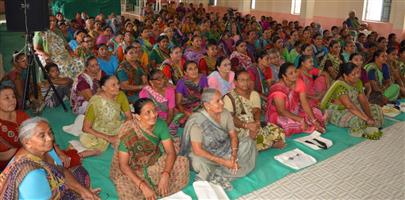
[{"left": 36, "top": 102, "right": 405, "bottom": 199}]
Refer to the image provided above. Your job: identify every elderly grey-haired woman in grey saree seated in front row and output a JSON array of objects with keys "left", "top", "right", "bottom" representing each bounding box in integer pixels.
[{"left": 181, "top": 88, "right": 257, "bottom": 189}]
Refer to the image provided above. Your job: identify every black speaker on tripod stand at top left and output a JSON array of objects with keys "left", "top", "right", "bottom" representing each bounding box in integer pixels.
[{"left": 5, "top": 0, "right": 49, "bottom": 32}]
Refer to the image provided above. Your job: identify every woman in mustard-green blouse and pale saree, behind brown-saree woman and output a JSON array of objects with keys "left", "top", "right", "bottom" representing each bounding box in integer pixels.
[{"left": 80, "top": 76, "right": 132, "bottom": 152}]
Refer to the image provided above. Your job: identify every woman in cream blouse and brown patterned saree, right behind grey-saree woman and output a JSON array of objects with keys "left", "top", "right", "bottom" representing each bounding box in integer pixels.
[{"left": 224, "top": 71, "right": 285, "bottom": 151}]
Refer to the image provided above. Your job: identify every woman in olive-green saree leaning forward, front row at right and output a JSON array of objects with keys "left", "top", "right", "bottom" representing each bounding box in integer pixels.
[{"left": 321, "top": 62, "right": 384, "bottom": 140}]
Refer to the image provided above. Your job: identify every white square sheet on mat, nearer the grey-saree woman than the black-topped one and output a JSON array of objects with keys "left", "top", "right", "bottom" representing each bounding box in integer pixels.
[{"left": 274, "top": 149, "right": 316, "bottom": 170}]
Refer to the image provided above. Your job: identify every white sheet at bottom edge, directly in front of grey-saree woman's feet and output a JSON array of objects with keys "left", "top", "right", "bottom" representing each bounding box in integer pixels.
[{"left": 193, "top": 181, "right": 229, "bottom": 200}]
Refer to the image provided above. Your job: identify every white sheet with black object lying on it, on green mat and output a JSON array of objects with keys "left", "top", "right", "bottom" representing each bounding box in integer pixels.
[{"left": 295, "top": 131, "right": 333, "bottom": 150}]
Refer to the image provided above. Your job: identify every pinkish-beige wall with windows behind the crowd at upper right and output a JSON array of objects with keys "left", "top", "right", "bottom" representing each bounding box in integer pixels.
[{"left": 188, "top": 0, "right": 405, "bottom": 39}]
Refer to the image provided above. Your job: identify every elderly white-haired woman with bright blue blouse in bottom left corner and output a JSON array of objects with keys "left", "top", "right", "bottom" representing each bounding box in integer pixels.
[{"left": 0, "top": 117, "right": 99, "bottom": 200}]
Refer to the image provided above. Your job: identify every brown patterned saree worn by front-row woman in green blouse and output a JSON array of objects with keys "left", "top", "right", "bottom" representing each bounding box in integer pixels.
[{"left": 110, "top": 127, "right": 190, "bottom": 200}]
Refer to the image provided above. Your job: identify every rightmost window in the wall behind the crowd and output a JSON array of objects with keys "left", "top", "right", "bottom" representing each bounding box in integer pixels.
[{"left": 363, "top": 0, "right": 392, "bottom": 22}]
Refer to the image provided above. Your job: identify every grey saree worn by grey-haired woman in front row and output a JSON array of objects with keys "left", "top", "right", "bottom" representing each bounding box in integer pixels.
[{"left": 180, "top": 110, "right": 257, "bottom": 188}]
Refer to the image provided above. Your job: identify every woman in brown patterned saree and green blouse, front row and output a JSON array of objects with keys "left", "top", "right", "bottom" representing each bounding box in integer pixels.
[{"left": 110, "top": 98, "right": 190, "bottom": 200}]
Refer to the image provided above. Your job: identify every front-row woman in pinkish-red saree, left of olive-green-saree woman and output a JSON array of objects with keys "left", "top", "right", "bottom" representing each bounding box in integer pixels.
[{"left": 266, "top": 63, "right": 325, "bottom": 136}]
